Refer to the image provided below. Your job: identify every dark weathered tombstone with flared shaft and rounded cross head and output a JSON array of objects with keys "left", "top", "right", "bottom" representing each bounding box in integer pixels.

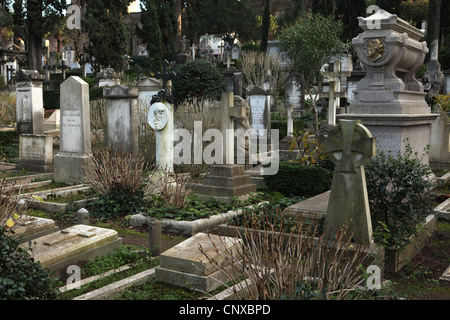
[{"left": 324, "top": 120, "right": 376, "bottom": 244}]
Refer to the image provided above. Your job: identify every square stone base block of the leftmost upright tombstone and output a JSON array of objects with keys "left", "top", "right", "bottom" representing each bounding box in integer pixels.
[{"left": 16, "top": 134, "right": 53, "bottom": 172}]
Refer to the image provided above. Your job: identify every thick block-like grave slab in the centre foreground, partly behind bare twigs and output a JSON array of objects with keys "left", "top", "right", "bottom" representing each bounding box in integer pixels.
[{"left": 155, "top": 233, "right": 241, "bottom": 292}]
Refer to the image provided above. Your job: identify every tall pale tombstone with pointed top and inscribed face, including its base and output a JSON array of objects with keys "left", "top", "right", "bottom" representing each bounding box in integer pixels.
[{"left": 54, "top": 76, "right": 91, "bottom": 184}]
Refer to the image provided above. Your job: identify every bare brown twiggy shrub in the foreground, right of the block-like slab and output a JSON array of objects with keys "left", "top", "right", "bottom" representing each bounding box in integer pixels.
[{"left": 199, "top": 208, "right": 369, "bottom": 300}]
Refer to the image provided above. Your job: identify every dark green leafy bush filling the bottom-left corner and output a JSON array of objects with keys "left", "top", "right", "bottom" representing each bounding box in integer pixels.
[{"left": 0, "top": 227, "right": 57, "bottom": 300}]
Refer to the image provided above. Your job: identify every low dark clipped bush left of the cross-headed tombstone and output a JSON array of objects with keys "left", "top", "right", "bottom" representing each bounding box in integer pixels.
[{"left": 264, "top": 162, "right": 331, "bottom": 197}]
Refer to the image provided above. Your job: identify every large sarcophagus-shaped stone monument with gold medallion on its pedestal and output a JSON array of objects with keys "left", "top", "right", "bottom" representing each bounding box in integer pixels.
[{"left": 337, "top": 10, "right": 437, "bottom": 163}]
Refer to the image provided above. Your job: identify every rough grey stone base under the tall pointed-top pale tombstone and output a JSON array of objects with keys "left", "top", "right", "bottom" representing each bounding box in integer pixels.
[{"left": 54, "top": 152, "right": 91, "bottom": 184}]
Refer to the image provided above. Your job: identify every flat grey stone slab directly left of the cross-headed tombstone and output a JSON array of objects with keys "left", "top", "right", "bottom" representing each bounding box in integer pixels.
[{"left": 282, "top": 191, "right": 330, "bottom": 219}]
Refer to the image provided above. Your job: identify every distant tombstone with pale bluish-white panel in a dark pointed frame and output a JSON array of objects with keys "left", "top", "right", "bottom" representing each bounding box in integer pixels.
[{"left": 247, "top": 86, "right": 271, "bottom": 136}]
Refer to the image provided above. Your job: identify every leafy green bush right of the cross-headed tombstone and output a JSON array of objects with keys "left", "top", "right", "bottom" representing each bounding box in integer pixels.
[{"left": 365, "top": 144, "right": 433, "bottom": 249}]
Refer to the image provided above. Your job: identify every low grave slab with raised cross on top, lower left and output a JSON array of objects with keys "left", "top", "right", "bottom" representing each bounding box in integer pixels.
[{"left": 21, "top": 225, "right": 123, "bottom": 271}]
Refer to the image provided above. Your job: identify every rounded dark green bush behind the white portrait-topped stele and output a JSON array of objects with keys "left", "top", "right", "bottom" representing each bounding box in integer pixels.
[{"left": 173, "top": 59, "right": 225, "bottom": 103}]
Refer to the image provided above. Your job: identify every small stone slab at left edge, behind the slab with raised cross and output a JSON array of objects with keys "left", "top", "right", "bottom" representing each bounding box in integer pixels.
[{"left": 12, "top": 216, "right": 59, "bottom": 243}]
